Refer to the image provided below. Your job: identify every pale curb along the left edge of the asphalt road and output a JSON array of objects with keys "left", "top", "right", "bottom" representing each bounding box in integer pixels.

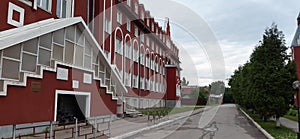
[{"left": 110, "top": 110, "right": 202, "bottom": 139}]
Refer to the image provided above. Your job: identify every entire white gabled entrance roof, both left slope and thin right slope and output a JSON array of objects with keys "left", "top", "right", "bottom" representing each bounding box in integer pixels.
[{"left": 0, "top": 17, "right": 127, "bottom": 92}]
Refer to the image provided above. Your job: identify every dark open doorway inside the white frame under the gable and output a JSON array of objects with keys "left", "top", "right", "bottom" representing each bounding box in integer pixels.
[{"left": 56, "top": 94, "right": 86, "bottom": 124}]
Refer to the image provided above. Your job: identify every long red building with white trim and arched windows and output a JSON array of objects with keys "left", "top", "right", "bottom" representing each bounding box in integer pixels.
[{"left": 0, "top": 0, "right": 181, "bottom": 126}]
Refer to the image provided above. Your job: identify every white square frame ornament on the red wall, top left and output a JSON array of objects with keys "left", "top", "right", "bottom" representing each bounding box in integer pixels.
[{"left": 7, "top": 2, "right": 25, "bottom": 27}]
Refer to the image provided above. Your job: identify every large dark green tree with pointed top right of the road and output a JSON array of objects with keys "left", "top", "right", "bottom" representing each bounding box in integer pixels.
[{"left": 229, "top": 24, "right": 297, "bottom": 126}]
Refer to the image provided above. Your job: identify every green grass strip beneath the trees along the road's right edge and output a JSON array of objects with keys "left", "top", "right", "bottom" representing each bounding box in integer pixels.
[{"left": 243, "top": 109, "right": 297, "bottom": 139}]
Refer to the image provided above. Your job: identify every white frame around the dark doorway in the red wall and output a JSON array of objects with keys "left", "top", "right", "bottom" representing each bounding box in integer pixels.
[{"left": 54, "top": 90, "right": 91, "bottom": 121}]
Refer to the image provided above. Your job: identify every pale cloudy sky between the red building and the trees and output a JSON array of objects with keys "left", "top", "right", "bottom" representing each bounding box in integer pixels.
[{"left": 140, "top": 0, "right": 300, "bottom": 86}]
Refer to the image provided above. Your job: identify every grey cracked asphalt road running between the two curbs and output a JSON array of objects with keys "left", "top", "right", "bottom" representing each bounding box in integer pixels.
[{"left": 128, "top": 104, "right": 265, "bottom": 139}]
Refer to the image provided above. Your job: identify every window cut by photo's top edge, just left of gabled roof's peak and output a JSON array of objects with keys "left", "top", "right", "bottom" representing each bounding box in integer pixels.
[{"left": 56, "top": 0, "right": 73, "bottom": 18}]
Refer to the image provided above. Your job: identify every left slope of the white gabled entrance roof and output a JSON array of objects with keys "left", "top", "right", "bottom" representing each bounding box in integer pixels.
[{"left": 0, "top": 17, "right": 85, "bottom": 50}]
